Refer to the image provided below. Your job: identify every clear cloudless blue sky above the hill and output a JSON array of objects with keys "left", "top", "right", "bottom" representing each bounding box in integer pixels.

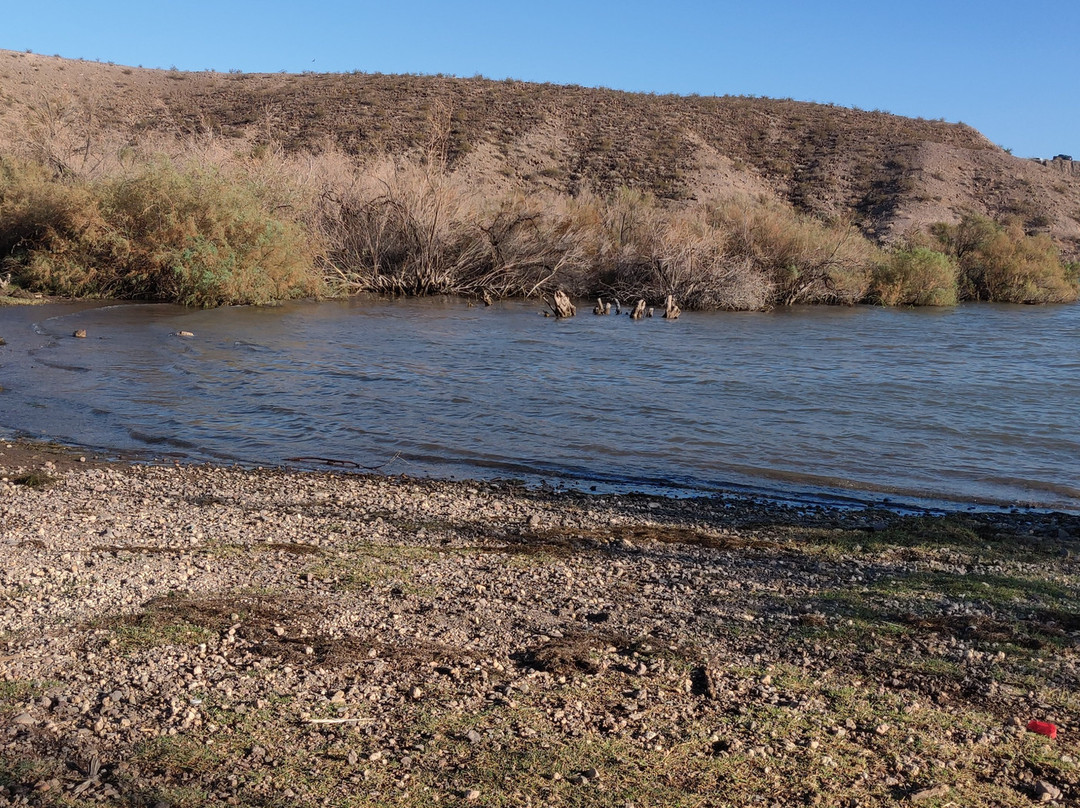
[{"left": 0, "top": 0, "right": 1080, "bottom": 159}]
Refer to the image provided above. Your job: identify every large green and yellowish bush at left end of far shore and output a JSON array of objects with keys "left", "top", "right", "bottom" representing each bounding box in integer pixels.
[{"left": 0, "top": 161, "right": 320, "bottom": 306}]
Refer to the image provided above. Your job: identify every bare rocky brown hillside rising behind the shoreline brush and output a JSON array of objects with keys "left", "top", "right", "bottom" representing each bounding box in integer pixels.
[{"left": 0, "top": 51, "right": 1080, "bottom": 256}]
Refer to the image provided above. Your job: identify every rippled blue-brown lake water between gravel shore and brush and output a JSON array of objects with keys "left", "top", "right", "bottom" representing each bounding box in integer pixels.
[{"left": 0, "top": 298, "right": 1080, "bottom": 512}]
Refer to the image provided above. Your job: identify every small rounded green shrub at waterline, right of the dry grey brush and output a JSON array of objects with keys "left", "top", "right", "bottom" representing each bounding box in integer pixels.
[{"left": 868, "top": 246, "right": 958, "bottom": 306}]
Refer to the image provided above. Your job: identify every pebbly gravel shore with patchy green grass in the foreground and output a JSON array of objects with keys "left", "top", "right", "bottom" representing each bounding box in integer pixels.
[{"left": 0, "top": 443, "right": 1080, "bottom": 807}]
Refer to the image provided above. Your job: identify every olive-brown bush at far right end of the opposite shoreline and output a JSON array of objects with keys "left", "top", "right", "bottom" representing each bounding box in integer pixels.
[{"left": 931, "top": 214, "right": 1080, "bottom": 304}]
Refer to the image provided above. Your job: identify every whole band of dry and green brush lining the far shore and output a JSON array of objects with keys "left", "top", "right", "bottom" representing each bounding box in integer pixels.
[{"left": 0, "top": 143, "right": 1078, "bottom": 310}]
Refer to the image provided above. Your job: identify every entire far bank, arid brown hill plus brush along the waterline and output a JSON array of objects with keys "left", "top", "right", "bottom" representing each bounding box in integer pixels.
[{"left": 0, "top": 52, "right": 1080, "bottom": 309}]
